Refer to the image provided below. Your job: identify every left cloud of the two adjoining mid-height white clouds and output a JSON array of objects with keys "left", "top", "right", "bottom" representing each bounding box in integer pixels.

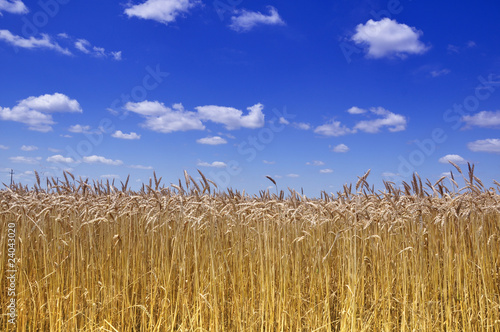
[{"left": 125, "top": 100, "right": 205, "bottom": 133}]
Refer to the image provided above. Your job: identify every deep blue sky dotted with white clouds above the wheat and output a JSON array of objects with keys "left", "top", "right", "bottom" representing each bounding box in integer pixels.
[{"left": 0, "top": 0, "right": 500, "bottom": 196}]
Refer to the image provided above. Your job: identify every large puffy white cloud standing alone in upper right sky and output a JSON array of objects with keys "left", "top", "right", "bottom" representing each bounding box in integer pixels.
[{"left": 352, "top": 18, "right": 428, "bottom": 58}]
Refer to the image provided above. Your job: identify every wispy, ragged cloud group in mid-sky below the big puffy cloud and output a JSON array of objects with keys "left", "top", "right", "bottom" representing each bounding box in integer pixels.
[{"left": 314, "top": 107, "right": 407, "bottom": 137}]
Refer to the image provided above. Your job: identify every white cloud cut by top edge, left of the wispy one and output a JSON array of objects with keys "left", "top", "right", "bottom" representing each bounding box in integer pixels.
[{"left": 125, "top": 0, "right": 199, "bottom": 25}]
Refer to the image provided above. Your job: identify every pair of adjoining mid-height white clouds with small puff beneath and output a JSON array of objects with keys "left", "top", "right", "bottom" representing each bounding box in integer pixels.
[{"left": 125, "top": 100, "right": 264, "bottom": 134}]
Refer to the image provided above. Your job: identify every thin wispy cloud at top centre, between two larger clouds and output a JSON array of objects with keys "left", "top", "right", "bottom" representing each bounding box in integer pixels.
[{"left": 229, "top": 6, "right": 285, "bottom": 32}]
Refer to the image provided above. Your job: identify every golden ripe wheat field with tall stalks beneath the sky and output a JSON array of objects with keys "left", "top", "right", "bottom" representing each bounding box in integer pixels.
[{"left": 0, "top": 165, "right": 500, "bottom": 331}]
